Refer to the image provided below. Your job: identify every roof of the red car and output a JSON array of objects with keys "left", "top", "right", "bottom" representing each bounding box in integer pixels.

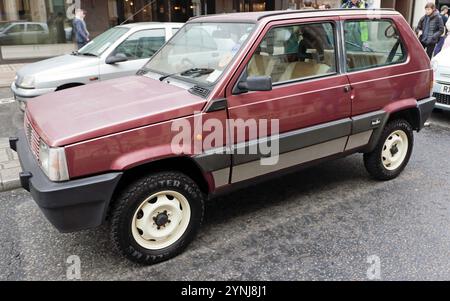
[{"left": 189, "top": 9, "right": 400, "bottom": 23}]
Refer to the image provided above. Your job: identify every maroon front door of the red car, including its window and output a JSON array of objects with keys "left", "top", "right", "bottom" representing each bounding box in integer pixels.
[{"left": 227, "top": 18, "right": 351, "bottom": 183}]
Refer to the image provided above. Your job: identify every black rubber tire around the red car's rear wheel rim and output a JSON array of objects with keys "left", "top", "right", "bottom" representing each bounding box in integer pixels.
[{"left": 364, "top": 119, "right": 414, "bottom": 181}]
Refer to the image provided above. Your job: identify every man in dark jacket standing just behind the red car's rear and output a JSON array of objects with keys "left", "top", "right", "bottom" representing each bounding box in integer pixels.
[{"left": 416, "top": 2, "right": 444, "bottom": 59}]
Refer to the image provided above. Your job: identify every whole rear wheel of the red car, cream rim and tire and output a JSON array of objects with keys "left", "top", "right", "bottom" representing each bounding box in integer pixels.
[{"left": 364, "top": 119, "right": 414, "bottom": 181}]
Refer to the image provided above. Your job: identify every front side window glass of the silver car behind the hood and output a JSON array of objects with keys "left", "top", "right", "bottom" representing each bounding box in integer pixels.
[{"left": 113, "top": 29, "right": 166, "bottom": 61}]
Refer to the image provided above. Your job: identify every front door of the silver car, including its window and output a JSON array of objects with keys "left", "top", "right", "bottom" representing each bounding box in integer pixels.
[{"left": 100, "top": 28, "right": 166, "bottom": 80}]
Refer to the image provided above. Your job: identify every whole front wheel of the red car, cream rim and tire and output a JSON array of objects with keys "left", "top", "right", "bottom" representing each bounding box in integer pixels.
[{"left": 111, "top": 172, "right": 204, "bottom": 264}]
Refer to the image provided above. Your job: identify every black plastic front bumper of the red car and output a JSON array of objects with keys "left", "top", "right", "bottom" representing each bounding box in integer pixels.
[{"left": 10, "top": 131, "right": 122, "bottom": 232}]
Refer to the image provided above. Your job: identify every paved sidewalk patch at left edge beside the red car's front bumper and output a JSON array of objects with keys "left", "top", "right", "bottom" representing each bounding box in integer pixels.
[{"left": 0, "top": 138, "right": 21, "bottom": 192}]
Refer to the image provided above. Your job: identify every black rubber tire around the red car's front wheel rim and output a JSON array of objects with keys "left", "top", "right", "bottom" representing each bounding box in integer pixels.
[{"left": 110, "top": 172, "right": 205, "bottom": 265}]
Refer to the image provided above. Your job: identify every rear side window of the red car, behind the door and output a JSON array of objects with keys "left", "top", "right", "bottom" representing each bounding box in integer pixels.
[{"left": 344, "top": 20, "right": 407, "bottom": 71}]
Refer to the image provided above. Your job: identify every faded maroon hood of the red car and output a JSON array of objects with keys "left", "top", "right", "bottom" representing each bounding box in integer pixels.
[{"left": 26, "top": 76, "right": 206, "bottom": 147}]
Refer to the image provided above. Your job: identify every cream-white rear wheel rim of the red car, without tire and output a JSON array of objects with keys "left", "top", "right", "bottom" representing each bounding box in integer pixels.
[{"left": 381, "top": 130, "right": 409, "bottom": 171}]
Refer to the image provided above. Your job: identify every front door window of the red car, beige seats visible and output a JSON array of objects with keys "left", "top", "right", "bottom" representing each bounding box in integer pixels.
[{"left": 247, "top": 23, "right": 336, "bottom": 83}]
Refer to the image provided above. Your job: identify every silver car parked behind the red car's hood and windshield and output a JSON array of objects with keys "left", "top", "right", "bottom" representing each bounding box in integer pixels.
[{"left": 11, "top": 23, "right": 184, "bottom": 110}]
